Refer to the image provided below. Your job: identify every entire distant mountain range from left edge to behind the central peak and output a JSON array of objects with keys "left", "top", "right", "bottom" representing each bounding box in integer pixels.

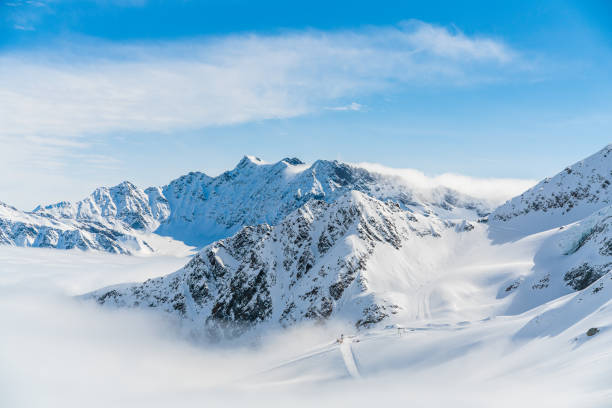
[{"left": 0, "top": 156, "right": 489, "bottom": 253}]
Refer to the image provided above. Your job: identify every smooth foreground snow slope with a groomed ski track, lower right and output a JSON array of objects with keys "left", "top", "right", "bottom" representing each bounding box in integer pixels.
[{"left": 249, "top": 274, "right": 612, "bottom": 407}]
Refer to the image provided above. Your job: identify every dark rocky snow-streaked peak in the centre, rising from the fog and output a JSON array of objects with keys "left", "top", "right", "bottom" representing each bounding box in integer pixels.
[{"left": 86, "top": 191, "right": 454, "bottom": 338}]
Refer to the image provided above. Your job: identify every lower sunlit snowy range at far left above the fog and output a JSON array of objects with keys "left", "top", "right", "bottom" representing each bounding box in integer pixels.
[{"left": 0, "top": 182, "right": 180, "bottom": 254}]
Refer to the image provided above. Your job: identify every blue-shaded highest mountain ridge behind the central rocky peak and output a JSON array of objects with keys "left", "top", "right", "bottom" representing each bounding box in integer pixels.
[{"left": 158, "top": 157, "right": 487, "bottom": 245}]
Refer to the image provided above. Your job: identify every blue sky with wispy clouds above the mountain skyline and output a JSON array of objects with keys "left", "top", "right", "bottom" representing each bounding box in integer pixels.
[{"left": 0, "top": 0, "right": 612, "bottom": 209}]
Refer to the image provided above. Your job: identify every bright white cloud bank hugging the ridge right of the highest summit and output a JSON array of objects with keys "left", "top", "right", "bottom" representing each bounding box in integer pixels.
[{"left": 356, "top": 163, "right": 537, "bottom": 207}]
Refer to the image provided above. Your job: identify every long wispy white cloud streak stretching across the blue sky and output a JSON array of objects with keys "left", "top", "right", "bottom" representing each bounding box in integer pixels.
[{"left": 0, "top": 22, "right": 516, "bottom": 141}]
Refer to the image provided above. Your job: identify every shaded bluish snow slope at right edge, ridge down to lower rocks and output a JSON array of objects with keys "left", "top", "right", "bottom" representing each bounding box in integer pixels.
[{"left": 482, "top": 145, "right": 612, "bottom": 313}]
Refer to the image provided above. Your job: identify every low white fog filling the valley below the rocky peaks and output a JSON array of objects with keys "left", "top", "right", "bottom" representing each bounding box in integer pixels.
[{"left": 0, "top": 247, "right": 612, "bottom": 407}]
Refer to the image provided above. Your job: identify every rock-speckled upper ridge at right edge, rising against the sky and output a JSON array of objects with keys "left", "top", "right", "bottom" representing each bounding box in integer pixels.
[{"left": 489, "top": 145, "right": 612, "bottom": 235}]
